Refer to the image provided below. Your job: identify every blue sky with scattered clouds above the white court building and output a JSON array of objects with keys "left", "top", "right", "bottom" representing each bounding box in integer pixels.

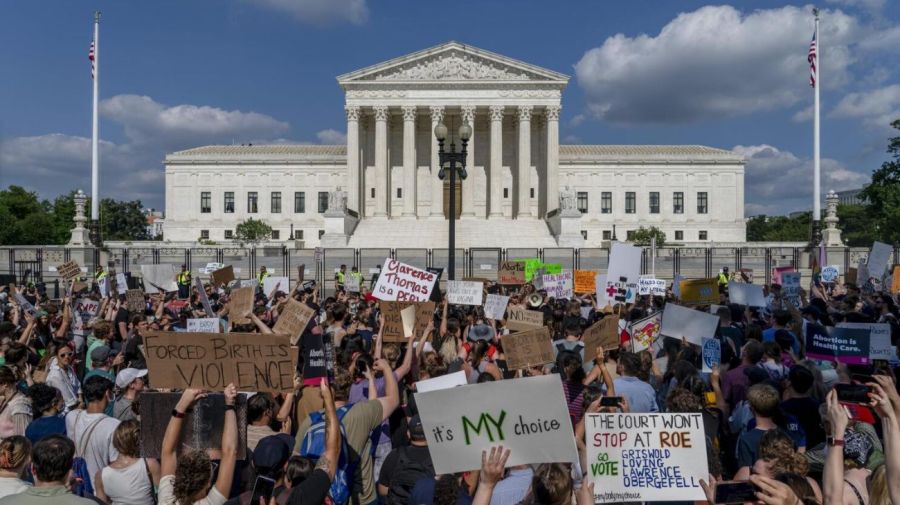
[{"left": 0, "top": 0, "right": 900, "bottom": 215}]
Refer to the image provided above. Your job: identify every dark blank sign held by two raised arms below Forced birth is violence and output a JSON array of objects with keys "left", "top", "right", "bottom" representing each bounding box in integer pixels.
[{"left": 140, "top": 392, "right": 247, "bottom": 460}]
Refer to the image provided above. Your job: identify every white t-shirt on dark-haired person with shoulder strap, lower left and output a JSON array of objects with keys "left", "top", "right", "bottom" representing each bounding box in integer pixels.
[{"left": 66, "top": 410, "right": 120, "bottom": 478}]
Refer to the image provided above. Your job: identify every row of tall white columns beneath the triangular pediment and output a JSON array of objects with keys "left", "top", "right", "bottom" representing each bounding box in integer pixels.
[{"left": 345, "top": 105, "right": 560, "bottom": 218}]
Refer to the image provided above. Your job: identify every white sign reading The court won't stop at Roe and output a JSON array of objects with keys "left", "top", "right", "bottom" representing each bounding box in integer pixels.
[{"left": 584, "top": 413, "right": 709, "bottom": 503}]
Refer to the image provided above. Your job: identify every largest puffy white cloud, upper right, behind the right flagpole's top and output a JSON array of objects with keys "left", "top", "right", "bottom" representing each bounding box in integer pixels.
[{"left": 575, "top": 6, "right": 861, "bottom": 123}]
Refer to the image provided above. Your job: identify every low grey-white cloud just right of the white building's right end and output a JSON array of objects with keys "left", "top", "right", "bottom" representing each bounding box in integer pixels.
[{"left": 732, "top": 144, "right": 869, "bottom": 216}]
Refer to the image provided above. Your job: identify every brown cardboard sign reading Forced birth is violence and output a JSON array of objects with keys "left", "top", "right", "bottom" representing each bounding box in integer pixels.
[{"left": 144, "top": 331, "right": 297, "bottom": 393}]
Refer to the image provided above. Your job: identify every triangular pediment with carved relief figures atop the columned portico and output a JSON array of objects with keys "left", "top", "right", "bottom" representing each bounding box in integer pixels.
[{"left": 337, "top": 42, "right": 569, "bottom": 86}]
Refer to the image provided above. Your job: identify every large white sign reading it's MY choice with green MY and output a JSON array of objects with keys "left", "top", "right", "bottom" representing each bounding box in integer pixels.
[{"left": 416, "top": 374, "right": 576, "bottom": 474}]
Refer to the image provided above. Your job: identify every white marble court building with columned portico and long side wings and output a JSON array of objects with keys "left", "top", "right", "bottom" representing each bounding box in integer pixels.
[{"left": 164, "top": 42, "right": 746, "bottom": 248}]
